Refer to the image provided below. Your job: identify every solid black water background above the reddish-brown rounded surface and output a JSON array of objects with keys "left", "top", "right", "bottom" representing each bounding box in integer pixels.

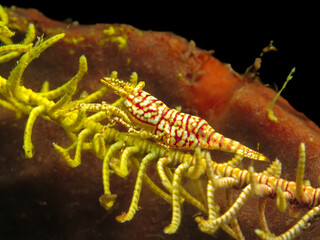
[{"left": 0, "top": 0, "right": 320, "bottom": 125}]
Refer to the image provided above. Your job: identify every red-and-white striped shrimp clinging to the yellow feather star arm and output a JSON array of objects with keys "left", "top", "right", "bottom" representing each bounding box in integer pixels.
[{"left": 95, "top": 73, "right": 268, "bottom": 161}]
